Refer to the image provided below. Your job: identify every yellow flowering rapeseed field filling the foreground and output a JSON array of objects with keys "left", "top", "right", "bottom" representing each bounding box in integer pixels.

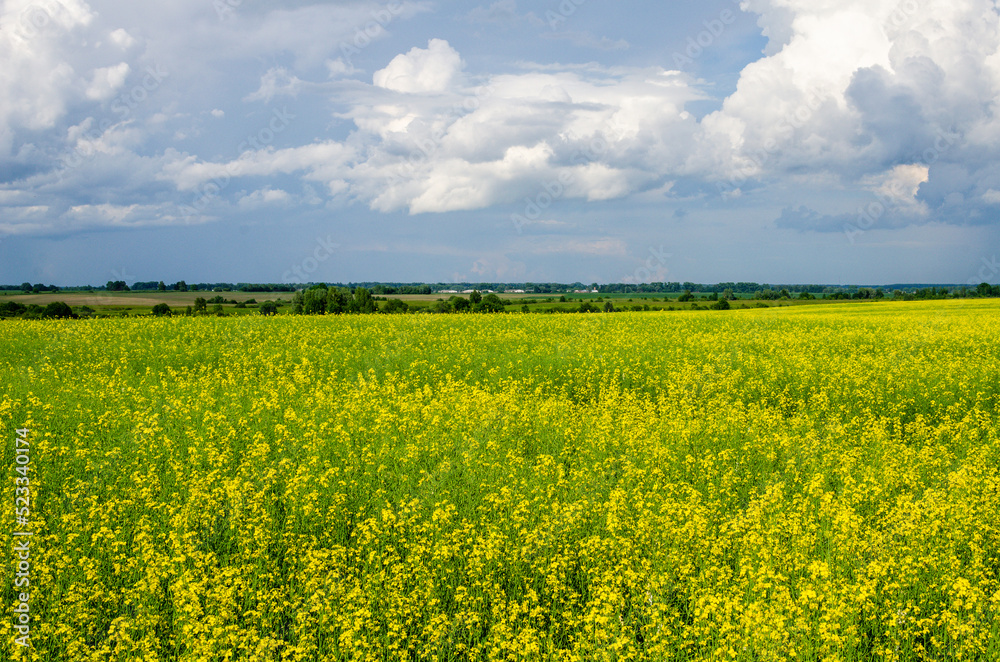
[{"left": 0, "top": 304, "right": 1000, "bottom": 662}]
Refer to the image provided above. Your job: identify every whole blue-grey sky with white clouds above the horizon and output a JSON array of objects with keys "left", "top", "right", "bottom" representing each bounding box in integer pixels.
[{"left": 0, "top": 0, "right": 1000, "bottom": 286}]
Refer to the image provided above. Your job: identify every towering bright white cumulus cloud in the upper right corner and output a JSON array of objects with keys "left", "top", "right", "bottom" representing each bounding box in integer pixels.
[{"left": 690, "top": 0, "right": 1000, "bottom": 205}]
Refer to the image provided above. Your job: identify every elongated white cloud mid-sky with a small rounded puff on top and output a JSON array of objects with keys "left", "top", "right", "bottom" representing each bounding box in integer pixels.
[{"left": 164, "top": 40, "right": 702, "bottom": 214}]
